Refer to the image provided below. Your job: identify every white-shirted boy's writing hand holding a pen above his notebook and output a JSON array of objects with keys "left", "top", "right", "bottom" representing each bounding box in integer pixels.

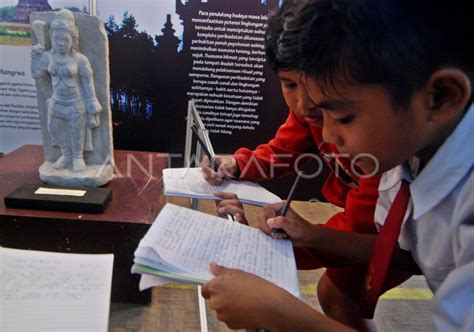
[{"left": 258, "top": 202, "right": 317, "bottom": 246}]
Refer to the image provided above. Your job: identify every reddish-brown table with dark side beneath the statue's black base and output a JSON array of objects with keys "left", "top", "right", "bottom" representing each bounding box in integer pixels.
[{"left": 0, "top": 145, "right": 168, "bottom": 303}]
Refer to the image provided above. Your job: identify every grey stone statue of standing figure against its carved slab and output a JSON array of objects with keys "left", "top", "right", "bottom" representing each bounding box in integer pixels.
[{"left": 30, "top": 9, "right": 113, "bottom": 186}]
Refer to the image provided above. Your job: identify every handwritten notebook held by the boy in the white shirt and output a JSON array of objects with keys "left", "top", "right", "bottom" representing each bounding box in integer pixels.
[{"left": 135, "top": 204, "right": 299, "bottom": 296}]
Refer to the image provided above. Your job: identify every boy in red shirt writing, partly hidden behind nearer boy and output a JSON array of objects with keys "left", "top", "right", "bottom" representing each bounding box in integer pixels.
[{"left": 201, "top": 0, "right": 410, "bottom": 328}]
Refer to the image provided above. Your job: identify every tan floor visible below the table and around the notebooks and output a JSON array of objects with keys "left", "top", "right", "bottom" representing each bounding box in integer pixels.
[{"left": 109, "top": 197, "right": 341, "bottom": 332}]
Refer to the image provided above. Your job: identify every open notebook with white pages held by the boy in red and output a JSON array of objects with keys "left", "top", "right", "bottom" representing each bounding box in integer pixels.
[{"left": 163, "top": 167, "right": 281, "bottom": 205}]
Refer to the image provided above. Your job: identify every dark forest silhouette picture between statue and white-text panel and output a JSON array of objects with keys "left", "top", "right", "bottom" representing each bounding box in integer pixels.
[{"left": 105, "top": 12, "right": 187, "bottom": 151}]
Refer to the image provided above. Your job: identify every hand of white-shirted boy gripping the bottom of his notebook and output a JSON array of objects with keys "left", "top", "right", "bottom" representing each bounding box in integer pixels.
[{"left": 202, "top": 263, "right": 291, "bottom": 329}]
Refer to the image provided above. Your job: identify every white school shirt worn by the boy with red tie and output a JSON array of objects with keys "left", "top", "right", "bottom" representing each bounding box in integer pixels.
[{"left": 375, "top": 106, "right": 474, "bottom": 332}]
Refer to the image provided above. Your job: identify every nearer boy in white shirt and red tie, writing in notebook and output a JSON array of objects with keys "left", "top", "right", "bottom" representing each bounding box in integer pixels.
[{"left": 203, "top": 0, "right": 474, "bottom": 331}]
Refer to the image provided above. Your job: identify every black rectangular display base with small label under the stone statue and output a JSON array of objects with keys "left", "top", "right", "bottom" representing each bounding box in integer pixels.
[{"left": 4, "top": 183, "right": 112, "bottom": 213}]
